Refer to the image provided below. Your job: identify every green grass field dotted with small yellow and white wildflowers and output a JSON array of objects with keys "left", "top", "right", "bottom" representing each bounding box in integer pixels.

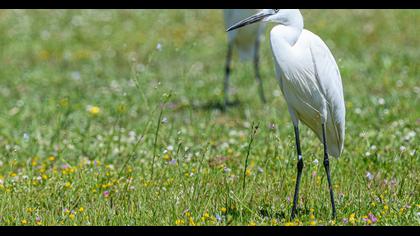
[{"left": 0, "top": 10, "right": 420, "bottom": 226}]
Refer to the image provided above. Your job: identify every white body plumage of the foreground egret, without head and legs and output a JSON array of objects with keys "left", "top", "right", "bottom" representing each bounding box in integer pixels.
[{"left": 270, "top": 25, "right": 345, "bottom": 157}]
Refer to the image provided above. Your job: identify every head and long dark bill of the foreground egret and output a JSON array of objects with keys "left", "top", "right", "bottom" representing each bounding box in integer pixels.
[{"left": 226, "top": 9, "right": 303, "bottom": 31}]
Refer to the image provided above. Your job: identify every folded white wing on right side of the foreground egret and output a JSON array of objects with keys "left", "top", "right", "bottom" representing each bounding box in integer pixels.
[{"left": 310, "top": 34, "right": 345, "bottom": 155}]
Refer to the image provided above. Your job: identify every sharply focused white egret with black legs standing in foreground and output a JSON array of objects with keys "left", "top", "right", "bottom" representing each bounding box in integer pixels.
[{"left": 227, "top": 9, "right": 345, "bottom": 219}]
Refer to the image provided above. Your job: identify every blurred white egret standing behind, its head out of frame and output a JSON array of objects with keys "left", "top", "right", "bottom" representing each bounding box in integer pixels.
[{"left": 223, "top": 9, "right": 266, "bottom": 108}]
